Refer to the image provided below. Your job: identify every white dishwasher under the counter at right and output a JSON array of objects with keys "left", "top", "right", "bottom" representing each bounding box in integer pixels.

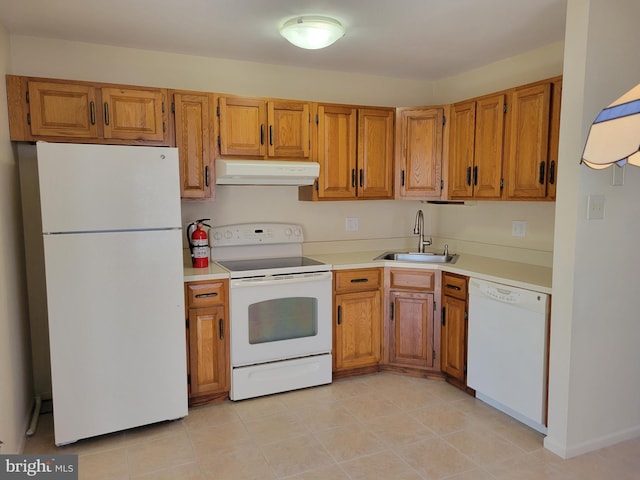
[{"left": 467, "top": 278, "right": 548, "bottom": 433}]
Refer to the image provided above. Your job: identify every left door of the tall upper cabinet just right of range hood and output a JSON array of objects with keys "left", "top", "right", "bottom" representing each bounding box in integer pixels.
[{"left": 318, "top": 105, "right": 357, "bottom": 199}]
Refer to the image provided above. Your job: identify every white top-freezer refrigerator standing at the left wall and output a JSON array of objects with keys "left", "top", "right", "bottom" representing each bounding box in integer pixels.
[{"left": 19, "top": 142, "right": 187, "bottom": 445}]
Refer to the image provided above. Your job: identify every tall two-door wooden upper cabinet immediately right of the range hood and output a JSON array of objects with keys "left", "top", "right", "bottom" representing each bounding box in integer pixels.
[{"left": 300, "top": 104, "right": 394, "bottom": 200}]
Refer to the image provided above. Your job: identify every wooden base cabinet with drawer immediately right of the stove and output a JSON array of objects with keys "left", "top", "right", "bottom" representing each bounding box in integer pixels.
[{"left": 333, "top": 268, "right": 382, "bottom": 378}]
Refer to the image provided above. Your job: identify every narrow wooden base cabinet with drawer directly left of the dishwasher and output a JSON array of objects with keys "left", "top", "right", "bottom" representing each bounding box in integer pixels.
[{"left": 441, "top": 272, "right": 468, "bottom": 389}]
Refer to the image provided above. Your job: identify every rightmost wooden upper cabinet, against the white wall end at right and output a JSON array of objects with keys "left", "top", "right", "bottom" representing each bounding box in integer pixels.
[{"left": 506, "top": 79, "right": 561, "bottom": 200}]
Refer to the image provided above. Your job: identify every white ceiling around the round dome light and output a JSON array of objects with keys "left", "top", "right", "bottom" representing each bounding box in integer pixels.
[{"left": 0, "top": 0, "right": 567, "bottom": 80}]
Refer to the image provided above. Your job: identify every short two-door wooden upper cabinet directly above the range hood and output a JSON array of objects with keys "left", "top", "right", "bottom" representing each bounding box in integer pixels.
[{"left": 218, "top": 96, "right": 311, "bottom": 160}]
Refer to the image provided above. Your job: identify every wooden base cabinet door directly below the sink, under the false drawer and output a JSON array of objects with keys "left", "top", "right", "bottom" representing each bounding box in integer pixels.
[{"left": 389, "top": 292, "right": 436, "bottom": 369}]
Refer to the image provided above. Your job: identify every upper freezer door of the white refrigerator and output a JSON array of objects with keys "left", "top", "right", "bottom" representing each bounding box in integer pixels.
[{"left": 36, "top": 142, "right": 181, "bottom": 233}]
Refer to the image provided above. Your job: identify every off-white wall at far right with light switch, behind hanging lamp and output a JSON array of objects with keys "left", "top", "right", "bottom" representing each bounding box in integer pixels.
[{"left": 545, "top": 0, "right": 640, "bottom": 457}]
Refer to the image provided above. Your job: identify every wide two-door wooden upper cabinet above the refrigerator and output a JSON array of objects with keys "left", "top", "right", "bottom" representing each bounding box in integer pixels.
[{"left": 7, "top": 75, "right": 170, "bottom": 145}]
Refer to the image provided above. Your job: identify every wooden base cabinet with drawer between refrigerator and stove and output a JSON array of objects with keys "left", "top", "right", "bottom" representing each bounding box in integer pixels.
[{"left": 185, "top": 280, "right": 230, "bottom": 406}]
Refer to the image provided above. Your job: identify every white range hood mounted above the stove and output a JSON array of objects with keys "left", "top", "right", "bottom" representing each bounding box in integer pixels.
[{"left": 216, "top": 159, "right": 320, "bottom": 185}]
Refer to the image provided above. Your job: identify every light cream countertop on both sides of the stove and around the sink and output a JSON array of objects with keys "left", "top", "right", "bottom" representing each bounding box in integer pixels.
[{"left": 184, "top": 250, "right": 552, "bottom": 293}]
